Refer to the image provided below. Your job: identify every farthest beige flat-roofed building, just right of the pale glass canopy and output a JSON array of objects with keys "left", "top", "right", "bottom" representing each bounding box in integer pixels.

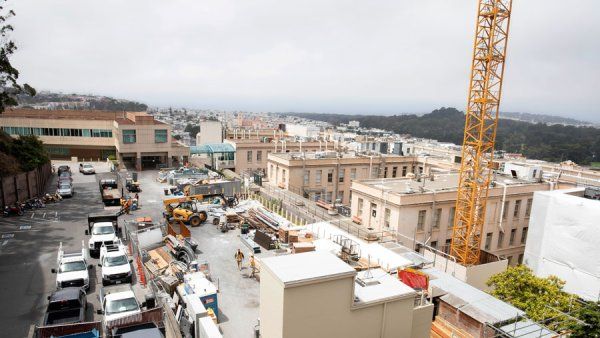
[{"left": 224, "top": 137, "right": 325, "bottom": 173}]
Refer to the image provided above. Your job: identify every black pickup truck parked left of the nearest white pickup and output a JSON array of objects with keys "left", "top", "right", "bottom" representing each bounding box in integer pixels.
[{"left": 44, "top": 287, "right": 87, "bottom": 326}]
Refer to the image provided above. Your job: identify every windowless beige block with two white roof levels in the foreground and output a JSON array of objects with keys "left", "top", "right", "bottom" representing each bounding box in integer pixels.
[{"left": 260, "top": 252, "right": 433, "bottom": 338}]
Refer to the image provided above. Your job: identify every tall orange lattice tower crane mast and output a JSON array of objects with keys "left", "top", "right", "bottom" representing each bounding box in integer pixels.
[{"left": 450, "top": 0, "right": 512, "bottom": 266}]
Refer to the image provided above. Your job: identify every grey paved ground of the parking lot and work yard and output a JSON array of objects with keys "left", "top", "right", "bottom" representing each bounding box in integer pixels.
[{"left": 0, "top": 162, "right": 264, "bottom": 337}]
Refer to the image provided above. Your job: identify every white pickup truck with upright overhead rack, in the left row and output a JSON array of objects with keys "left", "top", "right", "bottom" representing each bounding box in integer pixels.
[{"left": 52, "top": 241, "right": 92, "bottom": 290}]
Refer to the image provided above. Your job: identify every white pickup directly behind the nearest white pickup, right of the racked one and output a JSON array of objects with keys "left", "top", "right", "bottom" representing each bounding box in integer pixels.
[{"left": 98, "top": 241, "right": 133, "bottom": 286}]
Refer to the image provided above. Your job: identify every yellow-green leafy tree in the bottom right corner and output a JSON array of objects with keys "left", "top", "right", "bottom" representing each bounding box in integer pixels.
[{"left": 487, "top": 265, "right": 579, "bottom": 329}]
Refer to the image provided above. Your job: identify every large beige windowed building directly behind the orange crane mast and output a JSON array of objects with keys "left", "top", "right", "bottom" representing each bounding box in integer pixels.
[{"left": 351, "top": 173, "right": 564, "bottom": 265}]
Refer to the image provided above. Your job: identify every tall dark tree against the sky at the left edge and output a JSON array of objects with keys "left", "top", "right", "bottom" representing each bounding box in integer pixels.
[{"left": 0, "top": 0, "right": 35, "bottom": 113}]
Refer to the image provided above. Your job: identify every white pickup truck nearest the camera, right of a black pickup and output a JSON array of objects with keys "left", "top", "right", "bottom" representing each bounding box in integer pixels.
[{"left": 97, "top": 284, "right": 142, "bottom": 324}]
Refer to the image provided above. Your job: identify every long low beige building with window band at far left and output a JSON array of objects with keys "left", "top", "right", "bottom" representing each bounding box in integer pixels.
[{"left": 0, "top": 109, "right": 189, "bottom": 170}]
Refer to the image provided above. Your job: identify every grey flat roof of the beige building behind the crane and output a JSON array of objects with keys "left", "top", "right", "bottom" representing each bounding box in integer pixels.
[{"left": 356, "top": 173, "right": 532, "bottom": 195}]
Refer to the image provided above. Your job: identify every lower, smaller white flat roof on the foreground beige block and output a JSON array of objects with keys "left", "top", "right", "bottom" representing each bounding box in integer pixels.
[{"left": 354, "top": 269, "right": 417, "bottom": 305}]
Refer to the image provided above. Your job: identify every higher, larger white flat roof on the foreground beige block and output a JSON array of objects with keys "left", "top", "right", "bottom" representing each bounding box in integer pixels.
[{"left": 261, "top": 251, "right": 356, "bottom": 287}]
